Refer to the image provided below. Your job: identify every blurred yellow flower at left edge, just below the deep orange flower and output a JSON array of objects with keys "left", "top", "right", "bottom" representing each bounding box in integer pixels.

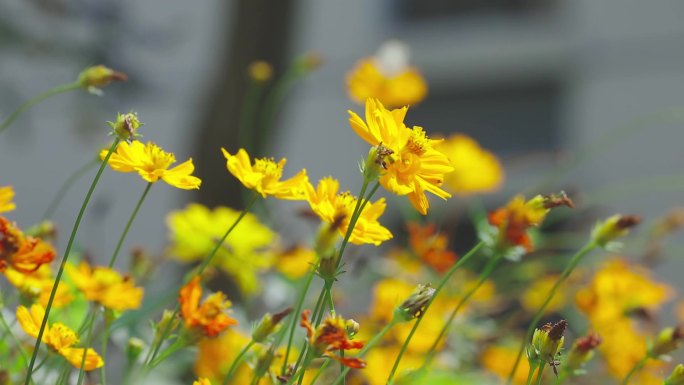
[{"left": 4, "top": 264, "right": 74, "bottom": 308}]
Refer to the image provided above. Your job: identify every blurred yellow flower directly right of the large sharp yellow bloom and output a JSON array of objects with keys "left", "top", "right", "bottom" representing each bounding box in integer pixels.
[{"left": 437, "top": 134, "right": 504, "bottom": 195}]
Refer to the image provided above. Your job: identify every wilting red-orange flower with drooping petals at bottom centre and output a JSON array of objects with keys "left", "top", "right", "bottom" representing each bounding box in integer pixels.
[{"left": 299, "top": 310, "right": 366, "bottom": 369}]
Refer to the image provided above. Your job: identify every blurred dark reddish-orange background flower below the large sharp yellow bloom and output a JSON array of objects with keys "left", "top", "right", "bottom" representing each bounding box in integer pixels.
[{"left": 408, "top": 223, "right": 458, "bottom": 273}]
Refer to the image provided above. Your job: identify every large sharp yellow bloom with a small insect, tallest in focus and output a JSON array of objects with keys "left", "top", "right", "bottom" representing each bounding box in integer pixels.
[{"left": 349, "top": 98, "right": 454, "bottom": 215}]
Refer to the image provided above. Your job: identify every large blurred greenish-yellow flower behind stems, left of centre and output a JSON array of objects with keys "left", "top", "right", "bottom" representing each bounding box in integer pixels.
[{"left": 166, "top": 203, "right": 276, "bottom": 294}]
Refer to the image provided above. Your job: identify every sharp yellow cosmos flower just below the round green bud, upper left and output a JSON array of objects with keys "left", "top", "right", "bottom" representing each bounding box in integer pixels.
[{"left": 100, "top": 141, "right": 202, "bottom": 190}]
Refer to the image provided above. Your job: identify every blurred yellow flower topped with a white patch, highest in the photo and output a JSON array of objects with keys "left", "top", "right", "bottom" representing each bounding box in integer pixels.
[{"left": 347, "top": 42, "right": 427, "bottom": 107}]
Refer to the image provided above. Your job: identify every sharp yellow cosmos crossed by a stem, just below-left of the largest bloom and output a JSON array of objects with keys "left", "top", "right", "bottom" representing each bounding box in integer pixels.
[{"left": 307, "top": 177, "right": 392, "bottom": 246}]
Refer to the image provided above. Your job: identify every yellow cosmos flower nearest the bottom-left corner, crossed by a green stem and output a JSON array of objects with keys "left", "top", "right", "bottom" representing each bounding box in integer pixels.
[{"left": 17, "top": 305, "right": 104, "bottom": 370}]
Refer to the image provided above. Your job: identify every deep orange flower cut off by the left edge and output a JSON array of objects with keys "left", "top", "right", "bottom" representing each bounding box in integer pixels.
[{"left": 0, "top": 217, "right": 55, "bottom": 273}]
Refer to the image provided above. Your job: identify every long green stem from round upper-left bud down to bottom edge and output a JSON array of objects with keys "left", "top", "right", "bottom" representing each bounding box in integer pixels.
[{"left": 24, "top": 138, "right": 120, "bottom": 385}]
